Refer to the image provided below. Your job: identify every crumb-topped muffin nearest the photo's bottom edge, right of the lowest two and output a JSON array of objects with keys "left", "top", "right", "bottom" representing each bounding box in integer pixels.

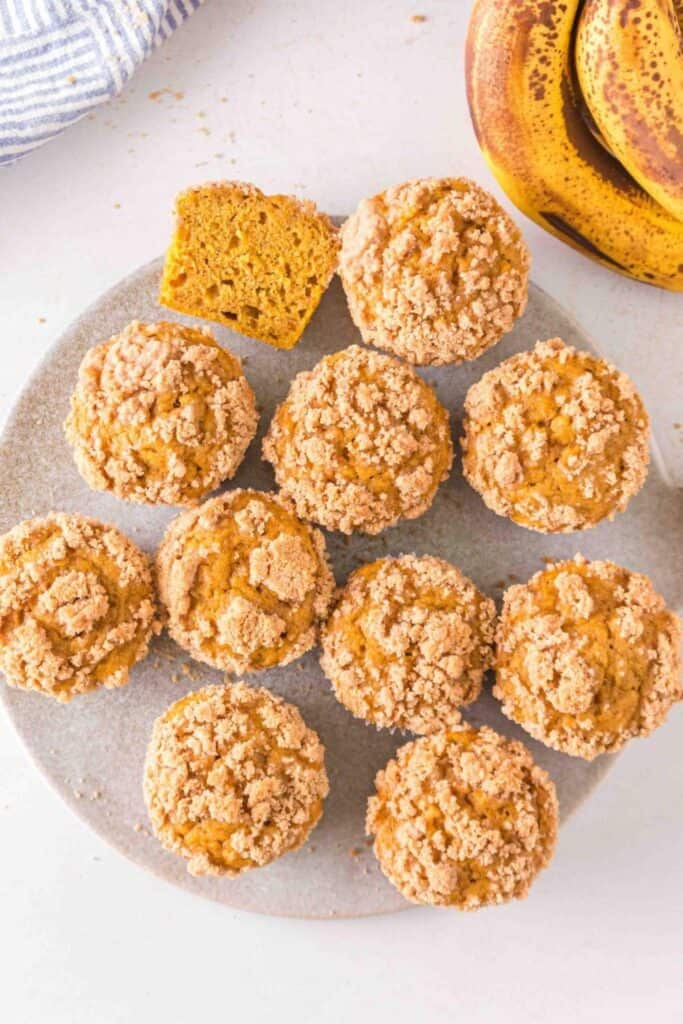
[{"left": 367, "top": 727, "right": 558, "bottom": 910}]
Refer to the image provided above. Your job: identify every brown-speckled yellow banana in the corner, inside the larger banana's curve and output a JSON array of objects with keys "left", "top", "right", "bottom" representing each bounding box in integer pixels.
[{"left": 575, "top": 0, "right": 683, "bottom": 220}]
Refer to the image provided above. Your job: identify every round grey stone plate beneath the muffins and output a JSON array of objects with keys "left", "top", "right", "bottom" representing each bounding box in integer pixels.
[{"left": 0, "top": 260, "right": 683, "bottom": 918}]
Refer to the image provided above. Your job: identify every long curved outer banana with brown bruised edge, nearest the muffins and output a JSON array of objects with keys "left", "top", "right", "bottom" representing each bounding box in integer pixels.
[{"left": 466, "top": 0, "right": 683, "bottom": 291}]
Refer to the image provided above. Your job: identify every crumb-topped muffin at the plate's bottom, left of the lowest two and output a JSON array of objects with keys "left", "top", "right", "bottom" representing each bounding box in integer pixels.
[{"left": 143, "top": 683, "right": 329, "bottom": 877}]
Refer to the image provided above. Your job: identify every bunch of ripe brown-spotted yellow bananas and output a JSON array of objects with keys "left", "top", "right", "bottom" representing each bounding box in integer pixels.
[{"left": 466, "top": 0, "right": 683, "bottom": 291}]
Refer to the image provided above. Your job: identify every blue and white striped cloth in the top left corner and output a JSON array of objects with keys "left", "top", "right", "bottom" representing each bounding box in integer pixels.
[{"left": 0, "top": 0, "right": 203, "bottom": 164}]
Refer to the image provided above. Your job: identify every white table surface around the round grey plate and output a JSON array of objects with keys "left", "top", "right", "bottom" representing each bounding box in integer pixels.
[{"left": 0, "top": 0, "right": 683, "bottom": 1024}]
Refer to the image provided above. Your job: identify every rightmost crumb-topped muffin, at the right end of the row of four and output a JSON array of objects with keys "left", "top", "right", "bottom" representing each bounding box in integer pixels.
[{"left": 494, "top": 555, "right": 683, "bottom": 761}]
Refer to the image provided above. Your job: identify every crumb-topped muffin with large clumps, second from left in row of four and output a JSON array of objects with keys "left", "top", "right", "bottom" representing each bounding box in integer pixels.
[{"left": 157, "top": 490, "right": 334, "bottom": 673}]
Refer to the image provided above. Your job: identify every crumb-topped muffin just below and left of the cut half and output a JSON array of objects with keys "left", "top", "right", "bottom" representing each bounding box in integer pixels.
[{"left": 65, "top": 321, "right": 258, "bottom": 505}]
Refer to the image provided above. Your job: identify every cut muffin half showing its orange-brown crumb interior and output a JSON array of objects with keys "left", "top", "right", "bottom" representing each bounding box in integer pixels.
[{"left": 159, "top": 181, "right": 339, "bottom": 348}]
